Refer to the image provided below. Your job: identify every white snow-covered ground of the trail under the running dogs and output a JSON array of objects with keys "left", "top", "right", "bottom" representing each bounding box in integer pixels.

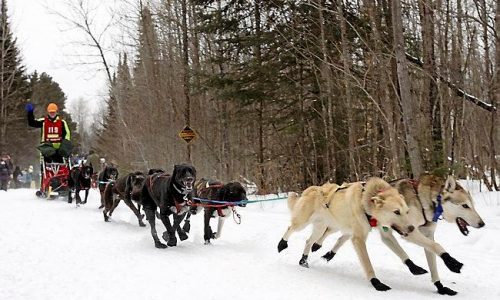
[{"left": 0, "top": 189, "right": 500, "bottom": 300}]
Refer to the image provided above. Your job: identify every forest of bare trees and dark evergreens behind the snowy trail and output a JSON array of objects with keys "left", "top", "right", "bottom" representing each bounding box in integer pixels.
[{"left": 0, "top": 0, "right": 500, "bottom": 193}]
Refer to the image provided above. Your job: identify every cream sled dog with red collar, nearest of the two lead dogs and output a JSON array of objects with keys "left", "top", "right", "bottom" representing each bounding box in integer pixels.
[{"left": 278, "top": 178, "right": 462, "bottom": 291}]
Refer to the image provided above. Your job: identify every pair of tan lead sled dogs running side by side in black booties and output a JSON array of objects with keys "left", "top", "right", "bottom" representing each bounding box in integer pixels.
[{"left": 278, "top": 175, "right": 485, "bottom": 295}]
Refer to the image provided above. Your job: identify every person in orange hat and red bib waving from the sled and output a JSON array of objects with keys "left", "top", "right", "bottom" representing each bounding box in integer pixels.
[{"left": 26, "top": 103, "right": 73, "bottom": 162}]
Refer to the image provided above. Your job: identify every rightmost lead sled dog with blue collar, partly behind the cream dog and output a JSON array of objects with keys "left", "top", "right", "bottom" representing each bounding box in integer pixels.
[{"left": 312, "top": 175, "right": 485, "bottom": 295}]
